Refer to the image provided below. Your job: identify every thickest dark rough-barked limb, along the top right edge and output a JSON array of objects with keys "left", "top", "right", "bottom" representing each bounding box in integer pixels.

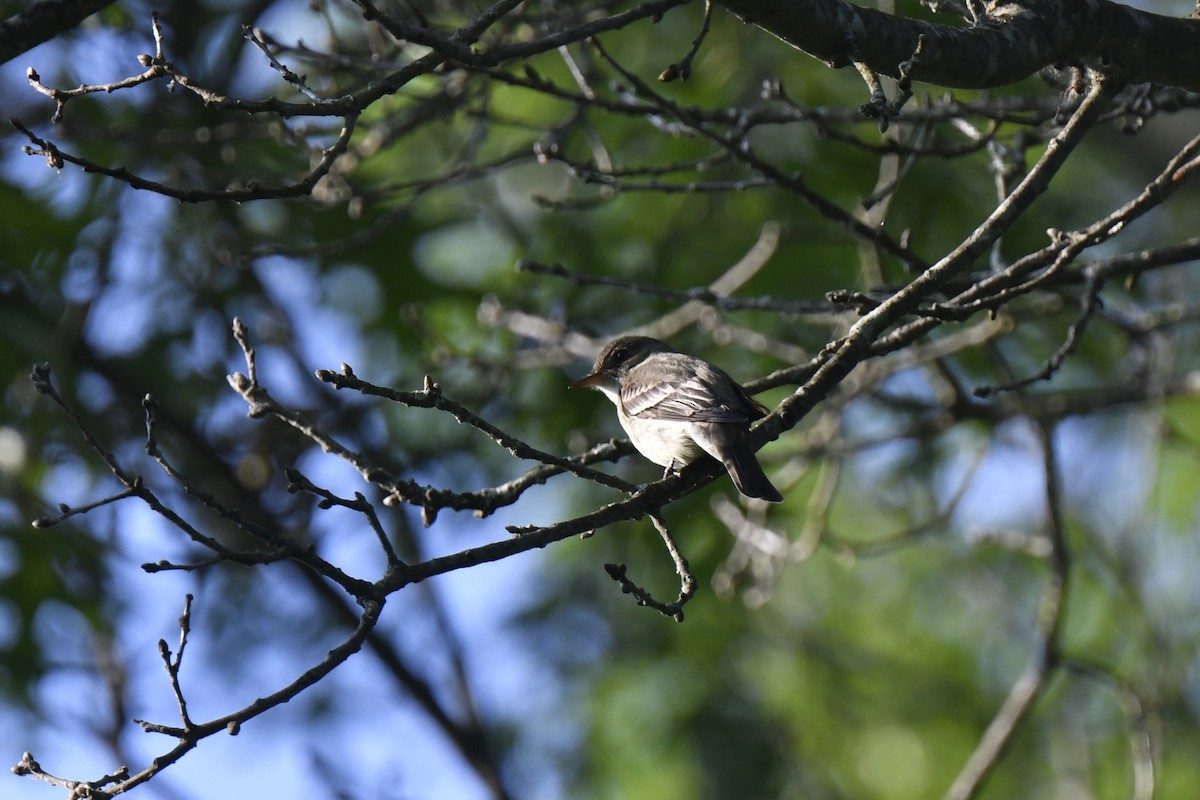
[{"left": 720, "top": 0, "right": 1200, "bottom": 90}]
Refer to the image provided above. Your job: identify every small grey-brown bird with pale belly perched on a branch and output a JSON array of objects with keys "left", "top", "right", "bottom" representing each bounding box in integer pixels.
[{"left": 570, "top": 336, "right": 784, "bottom": 503}]
